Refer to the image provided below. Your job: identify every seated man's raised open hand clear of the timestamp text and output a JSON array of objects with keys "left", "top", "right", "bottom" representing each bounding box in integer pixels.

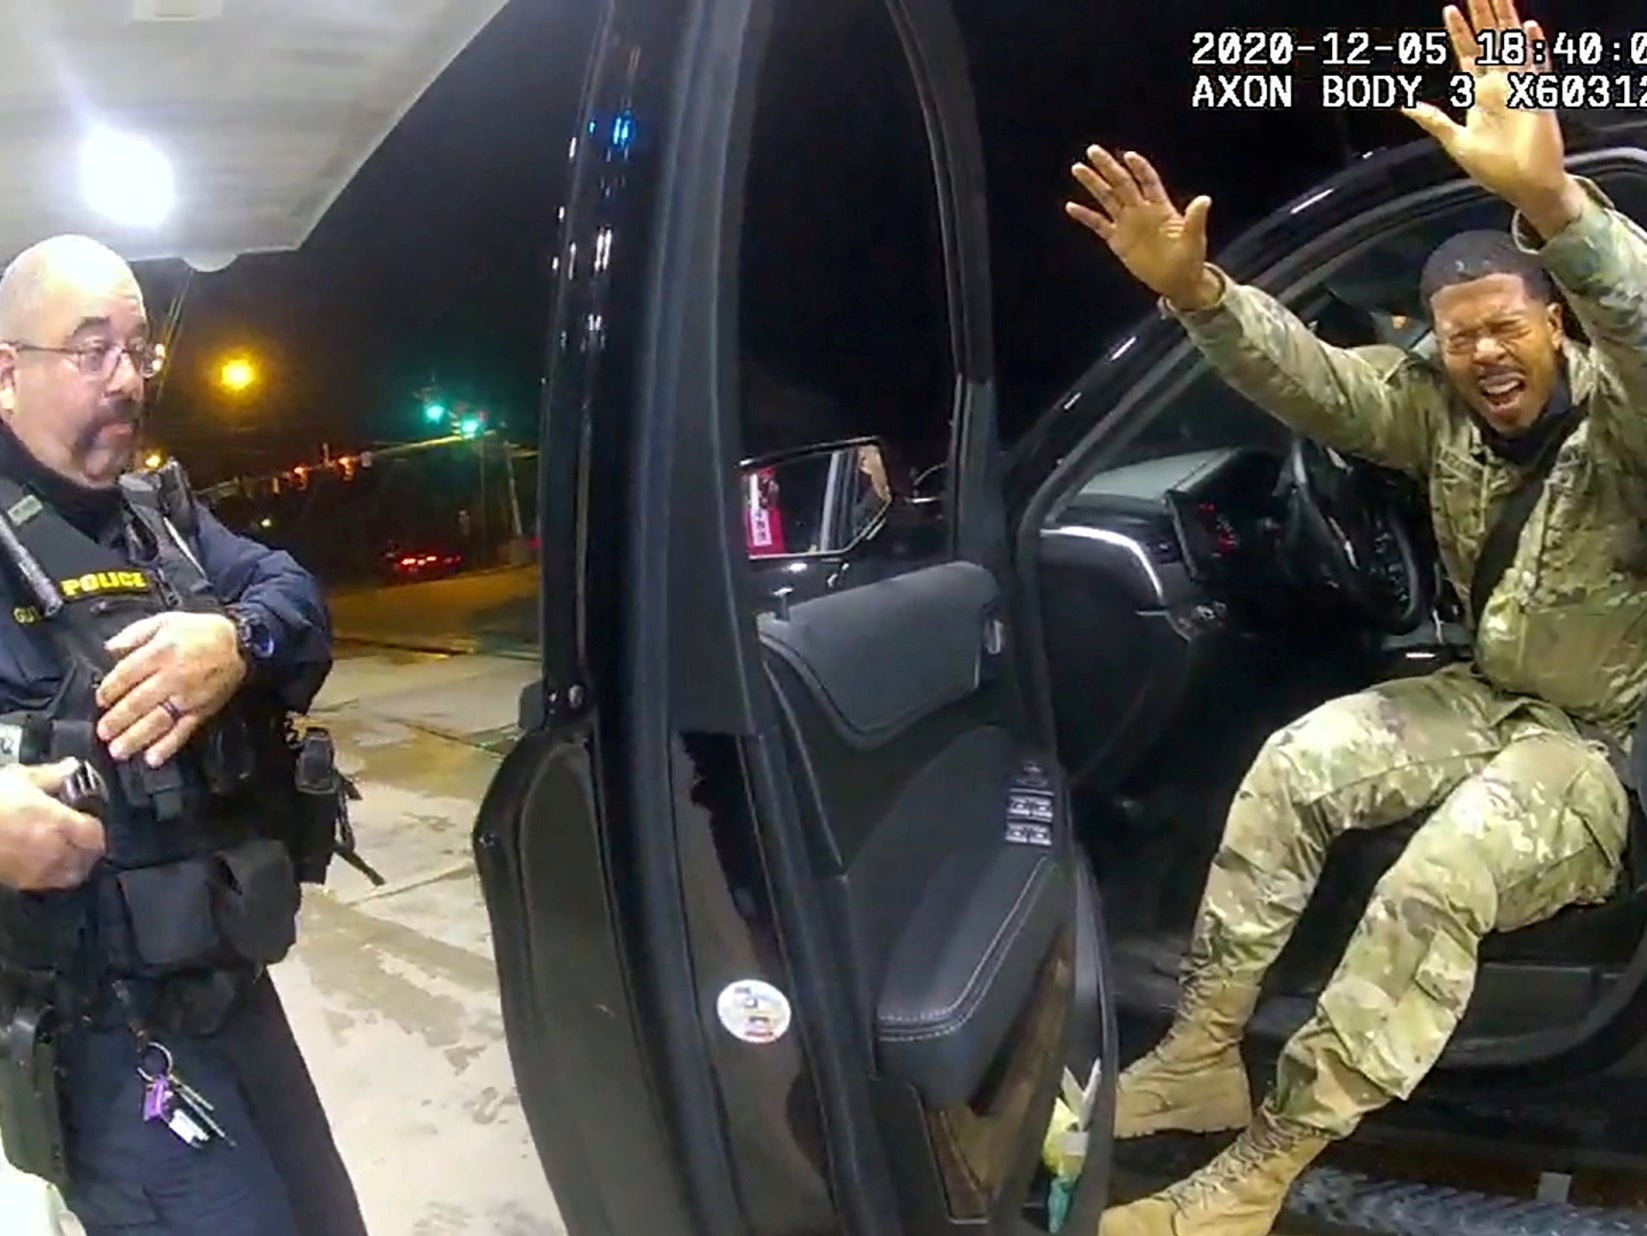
[{"left": 1064, "top": 147, "right": 1217, "bottom": 308}]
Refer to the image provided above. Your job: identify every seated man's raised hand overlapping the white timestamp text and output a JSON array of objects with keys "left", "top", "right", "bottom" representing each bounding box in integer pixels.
[{"left": 1402, "top": 0, "right": 1583, "bottom": 236}]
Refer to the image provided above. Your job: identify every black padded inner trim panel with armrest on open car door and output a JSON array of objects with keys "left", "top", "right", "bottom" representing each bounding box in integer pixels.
[{"left": 761, "top": 562, "right": 1074, "bottom": 1160}]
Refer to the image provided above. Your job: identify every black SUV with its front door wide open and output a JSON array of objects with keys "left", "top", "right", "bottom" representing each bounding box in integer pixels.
[{"left": 476, "top": 0, "right": 1647, "bottom": 1236}]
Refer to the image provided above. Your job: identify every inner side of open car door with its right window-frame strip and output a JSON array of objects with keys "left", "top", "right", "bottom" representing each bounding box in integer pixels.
[{"left": 727, "top": 0, "right": 1087, "bottom": 1233}]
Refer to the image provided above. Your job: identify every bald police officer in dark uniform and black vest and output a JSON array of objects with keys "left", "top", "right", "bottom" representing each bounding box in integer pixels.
[{"left": 0, "top": 236, "right": 364, "bottom": 1236}]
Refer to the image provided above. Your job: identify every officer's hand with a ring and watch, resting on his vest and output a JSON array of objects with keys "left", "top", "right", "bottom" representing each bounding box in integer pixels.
[{"left": 97, "top": 611, "right": 245, "bottom": 768}]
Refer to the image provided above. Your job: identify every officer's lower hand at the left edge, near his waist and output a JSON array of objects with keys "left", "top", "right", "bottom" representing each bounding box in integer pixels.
[{"left": 0, "top": 760, "right": 104, "bottom": 892}]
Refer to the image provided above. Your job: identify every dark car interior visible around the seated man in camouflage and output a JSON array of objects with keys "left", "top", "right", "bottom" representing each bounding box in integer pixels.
[{"left": 1034, "top": 180, "right": 1647, "bottom": 1094}]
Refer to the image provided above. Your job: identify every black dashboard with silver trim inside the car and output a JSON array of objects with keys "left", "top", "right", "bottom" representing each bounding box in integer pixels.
[{"left": 1036, "top": 447, "right": 1365, "bottom": 796}]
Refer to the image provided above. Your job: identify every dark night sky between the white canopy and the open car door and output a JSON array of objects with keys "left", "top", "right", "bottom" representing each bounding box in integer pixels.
[{"left": 143, "top": 0, "right": 588, "bottom": 480}]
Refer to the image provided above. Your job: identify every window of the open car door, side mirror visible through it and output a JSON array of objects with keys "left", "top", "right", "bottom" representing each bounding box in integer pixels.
[{"left": 736, "top": 0, "right": 955, "bottom": 582}]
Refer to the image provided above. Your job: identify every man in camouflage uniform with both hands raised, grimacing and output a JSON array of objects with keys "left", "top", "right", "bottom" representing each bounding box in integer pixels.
[{"left": 1069, "top": 0, "right": 1647, "bottom": 1236}]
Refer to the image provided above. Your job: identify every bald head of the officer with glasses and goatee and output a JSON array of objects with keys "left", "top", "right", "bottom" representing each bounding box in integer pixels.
[{"left": 0, "top": 236, "right": 148, "bottom": 488}]
